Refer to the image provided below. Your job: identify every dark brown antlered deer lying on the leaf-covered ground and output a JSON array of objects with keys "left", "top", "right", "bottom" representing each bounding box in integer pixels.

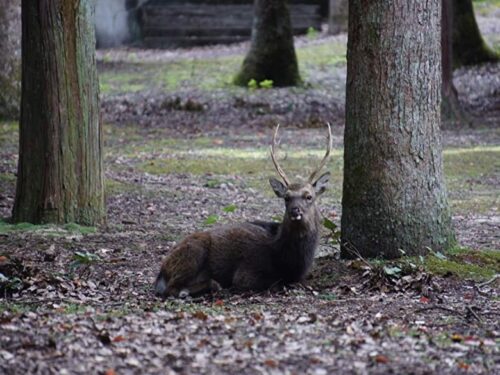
[{"left": 154, "top": 124, "right": 332, "bottom": 298}]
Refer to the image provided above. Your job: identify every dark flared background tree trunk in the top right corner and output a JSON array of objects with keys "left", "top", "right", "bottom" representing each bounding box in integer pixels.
[{"left": 452, "top": 0, "right": 499, "bottom": 68}]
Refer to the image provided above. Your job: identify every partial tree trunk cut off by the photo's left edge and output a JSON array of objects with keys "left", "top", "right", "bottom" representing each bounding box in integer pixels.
[{"left": 0, "top": 0, "right": 21, "bottom": 120}]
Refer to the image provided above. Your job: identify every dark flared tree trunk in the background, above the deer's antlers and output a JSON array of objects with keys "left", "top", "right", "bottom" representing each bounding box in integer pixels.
[{"left": 234, "top": 0, "right": 301, "bottom": 86}]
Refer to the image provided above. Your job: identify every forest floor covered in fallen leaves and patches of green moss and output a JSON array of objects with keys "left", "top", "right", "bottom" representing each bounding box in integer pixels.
[{"left": 0, "top": 5, "right": 500, "bottom": 375}]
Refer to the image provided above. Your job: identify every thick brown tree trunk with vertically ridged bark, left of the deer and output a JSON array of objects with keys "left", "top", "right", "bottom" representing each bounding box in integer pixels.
[{"left": 13, "top": 0, "right": 104, "bottom": 225}]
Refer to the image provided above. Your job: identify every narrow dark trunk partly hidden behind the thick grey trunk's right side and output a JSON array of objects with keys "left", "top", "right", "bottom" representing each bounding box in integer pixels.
[{"left": 441, "top": 0, "right": 472, "bottom": 128}]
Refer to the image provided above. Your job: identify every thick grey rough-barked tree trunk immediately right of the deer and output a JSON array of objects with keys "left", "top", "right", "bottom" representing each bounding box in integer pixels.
[{"left": 342, "top": 0, "right": 453, "bottom": 258}]
